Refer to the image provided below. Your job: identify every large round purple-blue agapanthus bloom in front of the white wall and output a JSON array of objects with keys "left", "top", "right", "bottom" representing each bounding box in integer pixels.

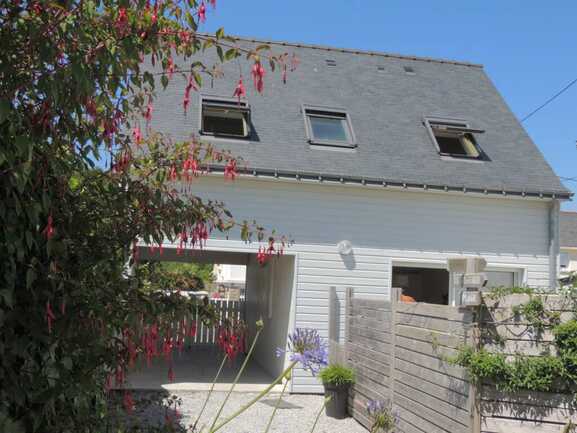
[{"left": 276, "top": 328, "right": 329, "bottom": 374}]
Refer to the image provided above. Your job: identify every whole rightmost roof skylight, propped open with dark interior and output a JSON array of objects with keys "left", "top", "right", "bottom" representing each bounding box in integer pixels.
[{"left": 425, "top": 119, "right": 484, "bottom": 159}]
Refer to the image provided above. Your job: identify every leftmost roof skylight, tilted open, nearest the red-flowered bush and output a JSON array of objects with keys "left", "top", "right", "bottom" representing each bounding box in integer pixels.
[{"left": 201, "top": 99, "right": 250, "bottom": 138}]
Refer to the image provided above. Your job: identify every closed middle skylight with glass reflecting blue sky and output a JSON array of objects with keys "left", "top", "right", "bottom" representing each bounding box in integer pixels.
[{"left": 304, "top": 108, "right": 354, "bottom": 147}]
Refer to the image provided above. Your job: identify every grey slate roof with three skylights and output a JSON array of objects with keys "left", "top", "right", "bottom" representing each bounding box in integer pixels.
[{"left": 152, "top": 39, "right": 571, "bottom": 198}]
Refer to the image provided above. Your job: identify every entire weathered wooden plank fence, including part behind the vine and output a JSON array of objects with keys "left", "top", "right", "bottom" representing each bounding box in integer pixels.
[{"left": 345, "top": 289, "right": 577, "bottom": 433}]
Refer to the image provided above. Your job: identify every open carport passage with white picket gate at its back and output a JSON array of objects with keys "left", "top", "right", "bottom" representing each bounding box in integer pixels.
[{"left": 128, "top": 248, "right": 294, "bottom": 391}]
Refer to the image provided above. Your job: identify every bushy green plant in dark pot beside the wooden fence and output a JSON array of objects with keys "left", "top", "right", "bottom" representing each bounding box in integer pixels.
[{"left": 319, "top": 364, "right": 355, "bottom": 419}]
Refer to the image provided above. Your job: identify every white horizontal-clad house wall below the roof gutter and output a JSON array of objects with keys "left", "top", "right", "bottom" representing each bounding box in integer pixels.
[{"left": 187, "top": 176, "right": 550, "bottom": 392}]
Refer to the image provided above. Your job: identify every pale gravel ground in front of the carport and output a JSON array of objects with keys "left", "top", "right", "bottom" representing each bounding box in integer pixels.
[{"left": 128, "top": 391, "right": 367, "bottom": 433}]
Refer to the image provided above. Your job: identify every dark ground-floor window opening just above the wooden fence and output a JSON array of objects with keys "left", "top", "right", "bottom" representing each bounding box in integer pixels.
[{"left": 393, "top": 266, "right": 449, "bottom": 305}]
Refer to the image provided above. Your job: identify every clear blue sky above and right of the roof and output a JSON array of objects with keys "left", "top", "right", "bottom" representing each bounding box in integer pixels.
[{"left": 204, "top": 0, "right": 577, "bottom": 210}]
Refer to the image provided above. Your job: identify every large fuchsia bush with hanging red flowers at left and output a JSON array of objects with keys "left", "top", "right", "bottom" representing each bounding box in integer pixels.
[{"left": 0, "top": 0, "right": 298, "bottom": 433}]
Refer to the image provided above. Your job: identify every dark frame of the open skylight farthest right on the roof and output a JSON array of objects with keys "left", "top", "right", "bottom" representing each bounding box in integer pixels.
[{"left": 423, "top": 116, "right": 485, "bottom": 161}]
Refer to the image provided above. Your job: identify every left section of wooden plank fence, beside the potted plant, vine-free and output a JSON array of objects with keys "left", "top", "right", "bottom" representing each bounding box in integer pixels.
[{"left": 346, "top": 289, "right": 475, "bottom": 433}]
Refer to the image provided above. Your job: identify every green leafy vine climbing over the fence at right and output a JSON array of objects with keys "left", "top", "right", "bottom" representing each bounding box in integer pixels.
[{"left": 449, "top": 288, "right": 577, "bottom": 393}]
